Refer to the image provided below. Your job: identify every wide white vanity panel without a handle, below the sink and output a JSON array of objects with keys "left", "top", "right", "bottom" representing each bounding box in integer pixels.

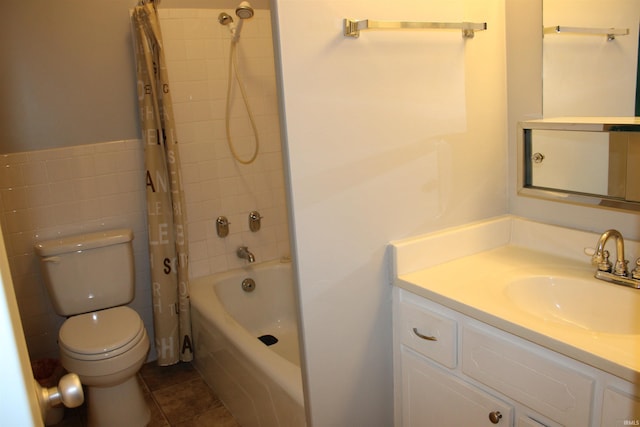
[{"left": 461, "top": 324, "right": 594, "bottom": 426}]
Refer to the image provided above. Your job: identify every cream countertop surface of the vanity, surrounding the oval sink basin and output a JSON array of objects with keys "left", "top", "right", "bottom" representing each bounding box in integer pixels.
[{"left": 394, "top": 245, "right": 640, "bottom": 383}]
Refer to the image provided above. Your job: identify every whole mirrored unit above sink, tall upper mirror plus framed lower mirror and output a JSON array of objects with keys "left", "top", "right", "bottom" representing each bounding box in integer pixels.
[{"left": 518, "top": 0, "right": 640, "bottom": 211}]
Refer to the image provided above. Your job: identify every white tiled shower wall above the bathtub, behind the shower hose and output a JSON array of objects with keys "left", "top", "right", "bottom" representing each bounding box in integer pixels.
[{"left": 159, "top": 8, "right": 289, "bottom": 277}]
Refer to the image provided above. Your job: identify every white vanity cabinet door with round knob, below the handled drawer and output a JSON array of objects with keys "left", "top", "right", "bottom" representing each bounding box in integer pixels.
[{"left": 400, "top": 346, "right": 513, "bottom": 427}]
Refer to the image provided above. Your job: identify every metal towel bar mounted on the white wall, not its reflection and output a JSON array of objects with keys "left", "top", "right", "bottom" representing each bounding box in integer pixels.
[{"left": 344, "top": 19, "right": 487, "bottom": 39}]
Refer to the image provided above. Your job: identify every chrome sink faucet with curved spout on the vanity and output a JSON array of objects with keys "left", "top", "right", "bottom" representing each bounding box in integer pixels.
[{"left": 591, "top": 230, "right": 640, "bottom": 289}]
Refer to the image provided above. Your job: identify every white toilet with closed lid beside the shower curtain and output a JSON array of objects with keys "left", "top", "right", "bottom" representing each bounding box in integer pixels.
[{"left": 35, "top": 229, "right": 150, "bottom": 427}]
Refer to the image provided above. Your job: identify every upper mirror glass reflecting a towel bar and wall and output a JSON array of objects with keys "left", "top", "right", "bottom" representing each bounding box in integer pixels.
[{"left": 542, "top": 0, "right": 640, "bottom": 117}]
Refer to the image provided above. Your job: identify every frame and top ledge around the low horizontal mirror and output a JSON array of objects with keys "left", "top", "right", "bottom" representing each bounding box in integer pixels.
[{"left": 517, "top": 117, "right": 640, "bottom": 212}]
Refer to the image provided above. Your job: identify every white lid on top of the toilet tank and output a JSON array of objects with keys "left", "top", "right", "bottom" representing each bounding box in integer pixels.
[{"left": 35, "top": 228, "right": 133, "bottom": 256}]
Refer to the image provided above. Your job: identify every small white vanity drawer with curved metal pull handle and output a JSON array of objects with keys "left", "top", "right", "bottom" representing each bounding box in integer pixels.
[{"left": 396, "top": 294, "right": 458, "bottom": 368}]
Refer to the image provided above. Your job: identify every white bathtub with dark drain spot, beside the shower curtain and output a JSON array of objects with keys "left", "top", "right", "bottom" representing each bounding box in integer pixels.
[{"left": 190, "top": 260, "right": 306, "bottom": 427}]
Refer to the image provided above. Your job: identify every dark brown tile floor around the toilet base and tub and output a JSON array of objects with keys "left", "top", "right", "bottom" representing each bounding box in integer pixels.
[{"left": 56, "top": 362, "right": 240, "bottom": 427}]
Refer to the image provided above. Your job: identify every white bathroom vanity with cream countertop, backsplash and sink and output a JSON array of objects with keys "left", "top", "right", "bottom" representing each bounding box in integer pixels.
[{"left": 391, "top": 216, "right": 640, "bottom": 427}]
